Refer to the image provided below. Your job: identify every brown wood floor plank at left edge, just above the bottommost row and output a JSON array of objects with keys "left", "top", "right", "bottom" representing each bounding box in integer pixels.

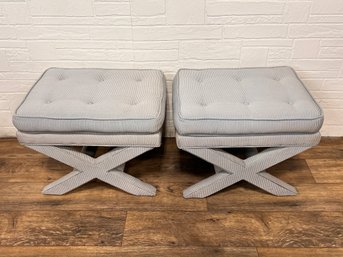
[{"left": 0, "top": 211, "right": 126, "bottom": 246}]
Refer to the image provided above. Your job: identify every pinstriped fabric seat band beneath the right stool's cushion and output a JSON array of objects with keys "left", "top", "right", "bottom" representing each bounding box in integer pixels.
[{"left": 176, "top": 132, "right": 320, "bottom": 149}]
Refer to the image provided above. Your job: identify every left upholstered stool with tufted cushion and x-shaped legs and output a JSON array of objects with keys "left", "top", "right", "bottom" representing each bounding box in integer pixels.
[{"left": 13, "top": 68, "right": 166, "bottom": 195}]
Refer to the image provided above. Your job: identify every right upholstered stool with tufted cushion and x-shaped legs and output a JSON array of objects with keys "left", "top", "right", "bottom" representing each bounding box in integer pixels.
[{"left": 173, "top": 67, "right": 323, "bottom": 198}]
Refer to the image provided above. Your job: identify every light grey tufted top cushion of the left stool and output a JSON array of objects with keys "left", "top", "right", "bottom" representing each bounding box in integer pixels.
[{"left": 13, "top": 68, "right": 166, "bottom": 133}]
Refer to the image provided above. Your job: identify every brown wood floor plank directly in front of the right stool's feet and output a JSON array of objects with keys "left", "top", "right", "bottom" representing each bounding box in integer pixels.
[{"left": 207, "top": 183, "right": 343, "bottom": 211}]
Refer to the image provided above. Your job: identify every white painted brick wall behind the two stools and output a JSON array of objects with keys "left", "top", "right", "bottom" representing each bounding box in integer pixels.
[{"left": 0, "top": 0, "right": 343, "bottom": 137}]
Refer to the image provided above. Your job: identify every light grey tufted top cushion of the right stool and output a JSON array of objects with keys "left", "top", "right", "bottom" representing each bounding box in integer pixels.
[{"left": 173, "top": 67, "right": 323, "bottom": 135}]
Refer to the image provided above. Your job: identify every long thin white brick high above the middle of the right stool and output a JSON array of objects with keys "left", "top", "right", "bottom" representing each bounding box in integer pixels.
[{"left": 223, "top": 25, "right": 287, "bottom": 39}]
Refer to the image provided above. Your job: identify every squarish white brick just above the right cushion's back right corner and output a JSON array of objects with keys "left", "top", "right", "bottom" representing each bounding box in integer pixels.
[{"left": 293, "top": 39, "right": 320, "bottom": 59}]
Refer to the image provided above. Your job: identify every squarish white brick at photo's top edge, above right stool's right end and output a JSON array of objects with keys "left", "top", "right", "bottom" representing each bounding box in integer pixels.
[{"left": 284, "top": 2, "right": 311, "bottom": 22}]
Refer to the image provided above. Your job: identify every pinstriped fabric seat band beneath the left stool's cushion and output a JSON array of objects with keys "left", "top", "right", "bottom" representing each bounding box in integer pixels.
[{"left": 17, "top": 131, "right": 162, "bottom": 147}]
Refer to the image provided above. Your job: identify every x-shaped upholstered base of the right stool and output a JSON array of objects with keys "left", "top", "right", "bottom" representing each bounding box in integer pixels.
[{"left": 183, "top": 147, "right": 310, "bottom": 198}]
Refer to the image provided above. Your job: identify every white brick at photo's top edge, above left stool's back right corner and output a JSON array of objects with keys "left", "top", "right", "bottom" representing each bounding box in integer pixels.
[{"left": 131, "top": 0, "right": 165, "bottom": 16}]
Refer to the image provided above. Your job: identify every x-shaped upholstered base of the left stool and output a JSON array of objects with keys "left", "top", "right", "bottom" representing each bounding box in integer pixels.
[{"left": 27, "top": 145, "right": 156, "bottom": 196}]
